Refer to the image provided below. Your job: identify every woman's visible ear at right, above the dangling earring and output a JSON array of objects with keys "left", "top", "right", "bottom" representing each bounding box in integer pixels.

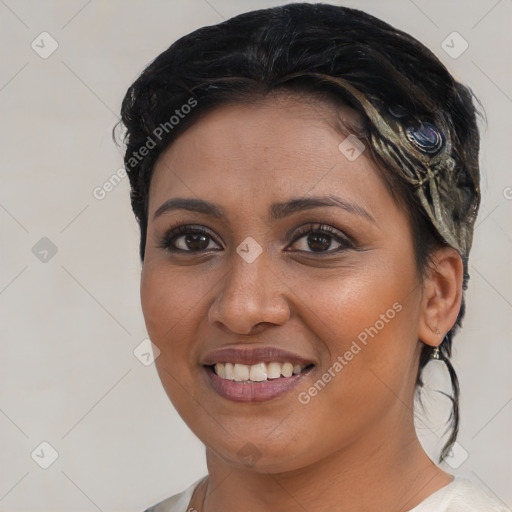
[{"left": 418, "top": 247, "right": 464, "bottom": 347}]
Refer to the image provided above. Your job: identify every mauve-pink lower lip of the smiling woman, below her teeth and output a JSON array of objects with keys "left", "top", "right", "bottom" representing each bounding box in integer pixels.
[{"left": 204, "top": 366, "right": 314, "bottom": 402}]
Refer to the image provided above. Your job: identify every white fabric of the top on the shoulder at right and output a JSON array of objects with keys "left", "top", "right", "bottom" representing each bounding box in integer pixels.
[{"left": 409, "top": 477, "right": 510, "bottom": 512}]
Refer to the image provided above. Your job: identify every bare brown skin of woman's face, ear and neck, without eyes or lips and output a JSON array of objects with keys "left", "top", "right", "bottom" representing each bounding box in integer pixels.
[{"left": 141, "top": 95, "right": 462, "bottom": 512}]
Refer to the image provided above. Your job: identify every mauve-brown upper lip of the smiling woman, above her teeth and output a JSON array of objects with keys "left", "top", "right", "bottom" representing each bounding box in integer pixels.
[{"left": 200, "top": 345, "right": 316, "bottom": 366}]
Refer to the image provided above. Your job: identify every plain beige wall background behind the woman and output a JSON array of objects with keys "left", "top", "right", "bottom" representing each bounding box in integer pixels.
[{"left": 0, "top": 0, "right": 512, "bottom": 512}]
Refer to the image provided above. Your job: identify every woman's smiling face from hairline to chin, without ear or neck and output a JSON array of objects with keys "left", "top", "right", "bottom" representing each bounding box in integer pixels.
[{"left": 141, "top": 97, "right": 422, "bottom": 472}]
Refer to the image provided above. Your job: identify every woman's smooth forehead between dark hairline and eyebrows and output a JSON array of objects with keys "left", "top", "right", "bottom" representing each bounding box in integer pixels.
[{"left": 150, "top": 95, "right": 392, "bottom": 217}]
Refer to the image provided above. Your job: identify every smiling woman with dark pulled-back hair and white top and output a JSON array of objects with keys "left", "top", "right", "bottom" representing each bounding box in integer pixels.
[{"left": 117, "top": 4, "right": 505, "bottom": 512}]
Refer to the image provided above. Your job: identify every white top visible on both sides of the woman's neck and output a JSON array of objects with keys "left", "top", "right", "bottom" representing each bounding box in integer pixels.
[{"left": 145, "top": 477, "right": 511, "bottom": 512}]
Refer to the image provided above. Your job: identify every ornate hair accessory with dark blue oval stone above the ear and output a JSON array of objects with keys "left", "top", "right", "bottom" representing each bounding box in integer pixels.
[{"left": 376, "top": 110, "right": 480, "bottom": 266}]
